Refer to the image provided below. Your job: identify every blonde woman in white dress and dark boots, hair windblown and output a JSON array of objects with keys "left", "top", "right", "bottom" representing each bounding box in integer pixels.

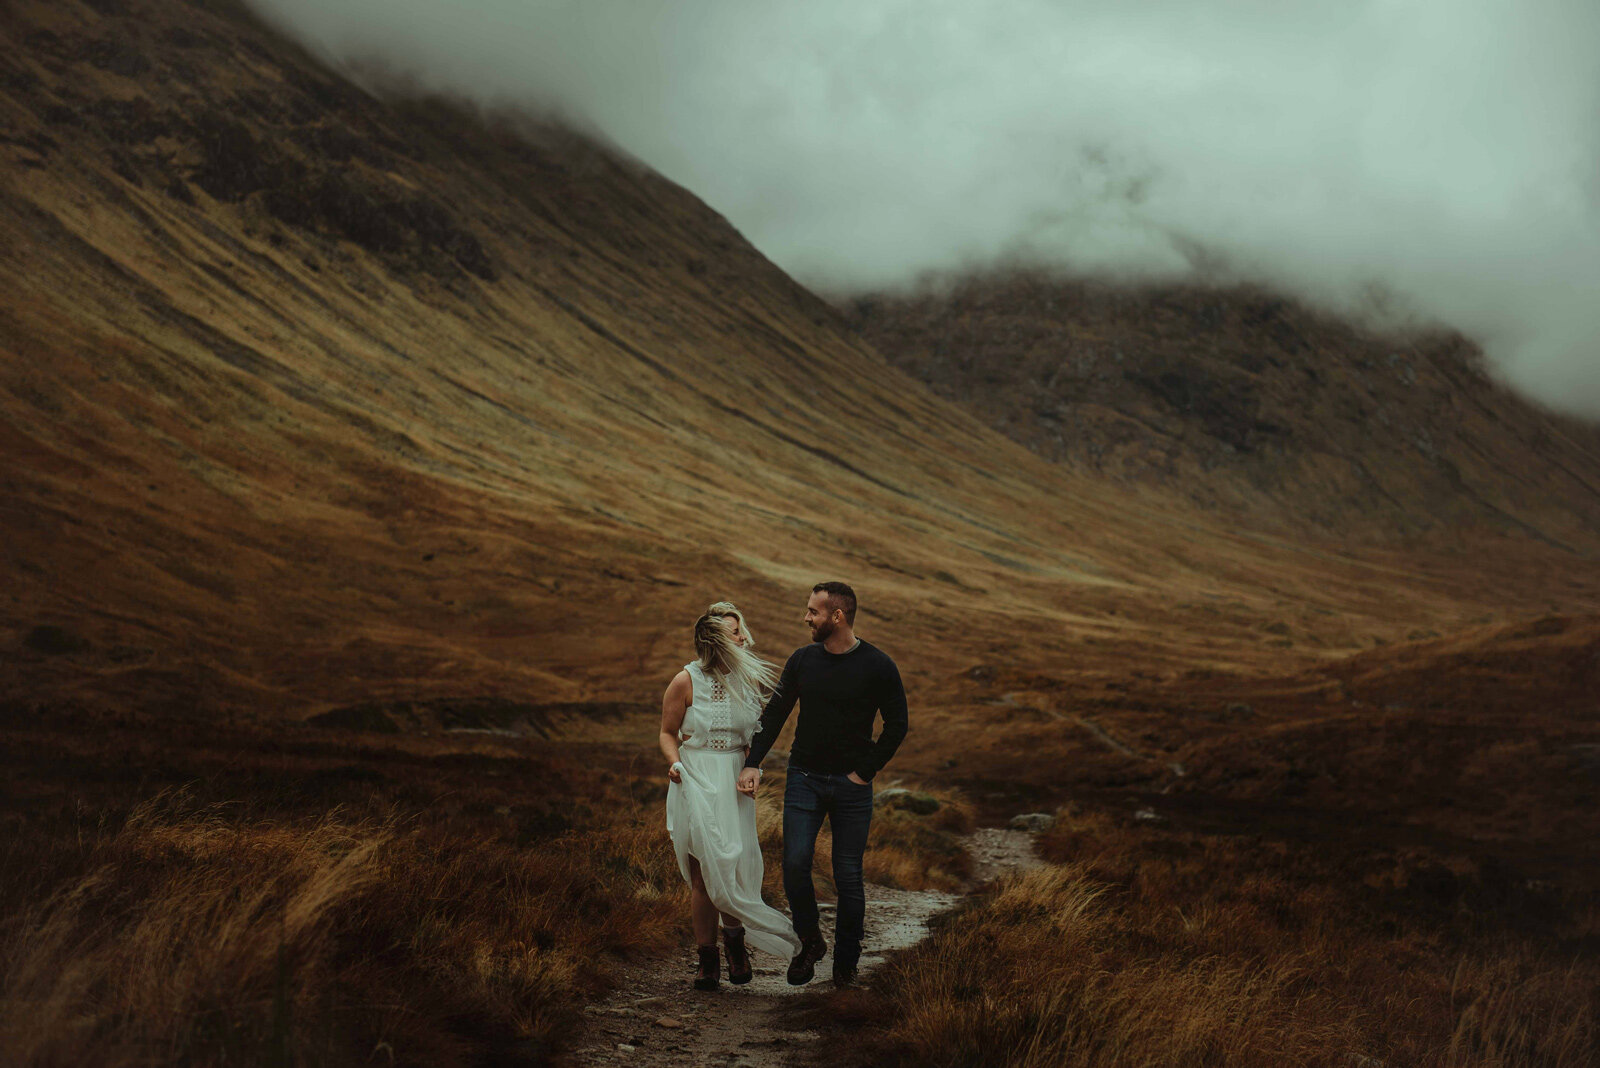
[{"left": 661, "top": 601, "right": 800, "bottom": 990}]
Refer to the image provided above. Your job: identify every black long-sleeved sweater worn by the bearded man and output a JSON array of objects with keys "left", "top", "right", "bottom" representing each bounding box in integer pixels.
[{"left": 744, "top": 641, "right": 907, "bottom": 782}]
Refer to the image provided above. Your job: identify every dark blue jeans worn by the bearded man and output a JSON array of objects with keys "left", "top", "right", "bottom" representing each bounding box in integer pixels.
[{"left": 784, "top": 764, "right": 872, "bottom": 969}]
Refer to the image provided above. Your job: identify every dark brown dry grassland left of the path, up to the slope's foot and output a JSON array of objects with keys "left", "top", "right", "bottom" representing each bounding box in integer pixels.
[{"left": 0, "top": 713, "right": 700, "bottom": 1066}]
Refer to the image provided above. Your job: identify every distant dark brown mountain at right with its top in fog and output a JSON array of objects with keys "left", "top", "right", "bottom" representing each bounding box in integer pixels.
[{"left": 850, "top": 275, "right": 1600, "bottom": 546}]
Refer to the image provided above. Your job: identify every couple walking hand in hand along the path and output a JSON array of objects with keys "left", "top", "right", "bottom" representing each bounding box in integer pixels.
[{"left": 661, "top": 582, "right": 907, "bottom": 990}]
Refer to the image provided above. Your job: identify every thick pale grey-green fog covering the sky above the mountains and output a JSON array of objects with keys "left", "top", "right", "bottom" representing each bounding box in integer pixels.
[{"left": 251, "top": 0, "right": 1600, "bottom": 416}]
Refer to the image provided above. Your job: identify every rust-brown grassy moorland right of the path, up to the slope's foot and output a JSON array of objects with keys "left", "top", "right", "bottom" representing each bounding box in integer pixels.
[{"left": 802, "top": 617, "right": 1600, "bottom": 1068}]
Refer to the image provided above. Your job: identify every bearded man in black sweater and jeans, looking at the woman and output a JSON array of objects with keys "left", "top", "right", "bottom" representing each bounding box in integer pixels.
[{"left": 739, "top": 582, "right": 907, "bottom": 986}]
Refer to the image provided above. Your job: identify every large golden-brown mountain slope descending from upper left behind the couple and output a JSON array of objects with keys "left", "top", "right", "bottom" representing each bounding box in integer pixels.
[{"left": 0, "top": 0, "right": 1600, "bottom": 725}]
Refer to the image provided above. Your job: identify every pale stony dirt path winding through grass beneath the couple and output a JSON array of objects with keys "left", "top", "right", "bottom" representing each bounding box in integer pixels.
[{"left": 573, "top": 828, "right": 1038, "bottom": 1068}]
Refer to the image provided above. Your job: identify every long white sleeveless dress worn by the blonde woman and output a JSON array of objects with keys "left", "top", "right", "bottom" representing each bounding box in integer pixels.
[{"left": 667, "top": 664, "right": 800, "bottom": 961}]
